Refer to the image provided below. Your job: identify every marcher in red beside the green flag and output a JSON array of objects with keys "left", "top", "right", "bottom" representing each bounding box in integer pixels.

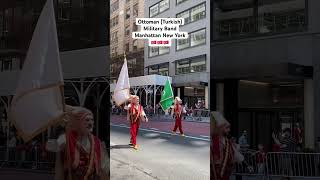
[{"left": 172, "top": 97, "right": 184, "bottom": 136}]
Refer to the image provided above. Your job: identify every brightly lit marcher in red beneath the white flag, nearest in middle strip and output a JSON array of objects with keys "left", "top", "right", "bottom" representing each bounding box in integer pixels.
[{"left": 127, "top": 95, "right": 148, "bottom": 150}]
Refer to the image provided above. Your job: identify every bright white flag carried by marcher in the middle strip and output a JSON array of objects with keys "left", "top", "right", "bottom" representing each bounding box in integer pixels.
[{"left": 113, "top": 58, "right": 130, "bottom": 106}]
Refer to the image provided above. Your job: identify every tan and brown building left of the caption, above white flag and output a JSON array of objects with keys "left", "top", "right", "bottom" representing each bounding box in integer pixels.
[{"left": 110, "top": 0, "right": 144, "bottom": 81}]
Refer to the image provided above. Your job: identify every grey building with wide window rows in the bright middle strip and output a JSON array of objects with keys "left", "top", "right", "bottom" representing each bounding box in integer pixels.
[{"left": 144, "top": 0, "right": 210, "bottom": 108}]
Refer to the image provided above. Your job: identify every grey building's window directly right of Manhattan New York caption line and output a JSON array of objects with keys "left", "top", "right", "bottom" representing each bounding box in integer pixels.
[{"left": 176, "top": 29, "right": 206, "bottom": 50}]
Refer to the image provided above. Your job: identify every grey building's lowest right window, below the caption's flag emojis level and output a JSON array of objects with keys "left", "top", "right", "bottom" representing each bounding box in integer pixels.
[{"left": 176, "top": 55, "right": 207, "bottom": 75}]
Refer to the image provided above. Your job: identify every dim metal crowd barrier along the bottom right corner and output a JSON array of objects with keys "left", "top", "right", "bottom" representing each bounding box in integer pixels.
[{"left": 233, "top": 151, "right": 320, "bottom": 179}]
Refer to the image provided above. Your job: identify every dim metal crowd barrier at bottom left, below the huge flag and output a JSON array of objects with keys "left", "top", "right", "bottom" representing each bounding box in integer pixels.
[{"left": 0, "top": 145, "right": 55, "bottom": 171}]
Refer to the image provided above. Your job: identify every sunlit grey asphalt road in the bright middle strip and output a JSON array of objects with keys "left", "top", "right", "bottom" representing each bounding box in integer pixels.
[{"left": 110, "top": 124, "right": 210, "bottom": 180}]
